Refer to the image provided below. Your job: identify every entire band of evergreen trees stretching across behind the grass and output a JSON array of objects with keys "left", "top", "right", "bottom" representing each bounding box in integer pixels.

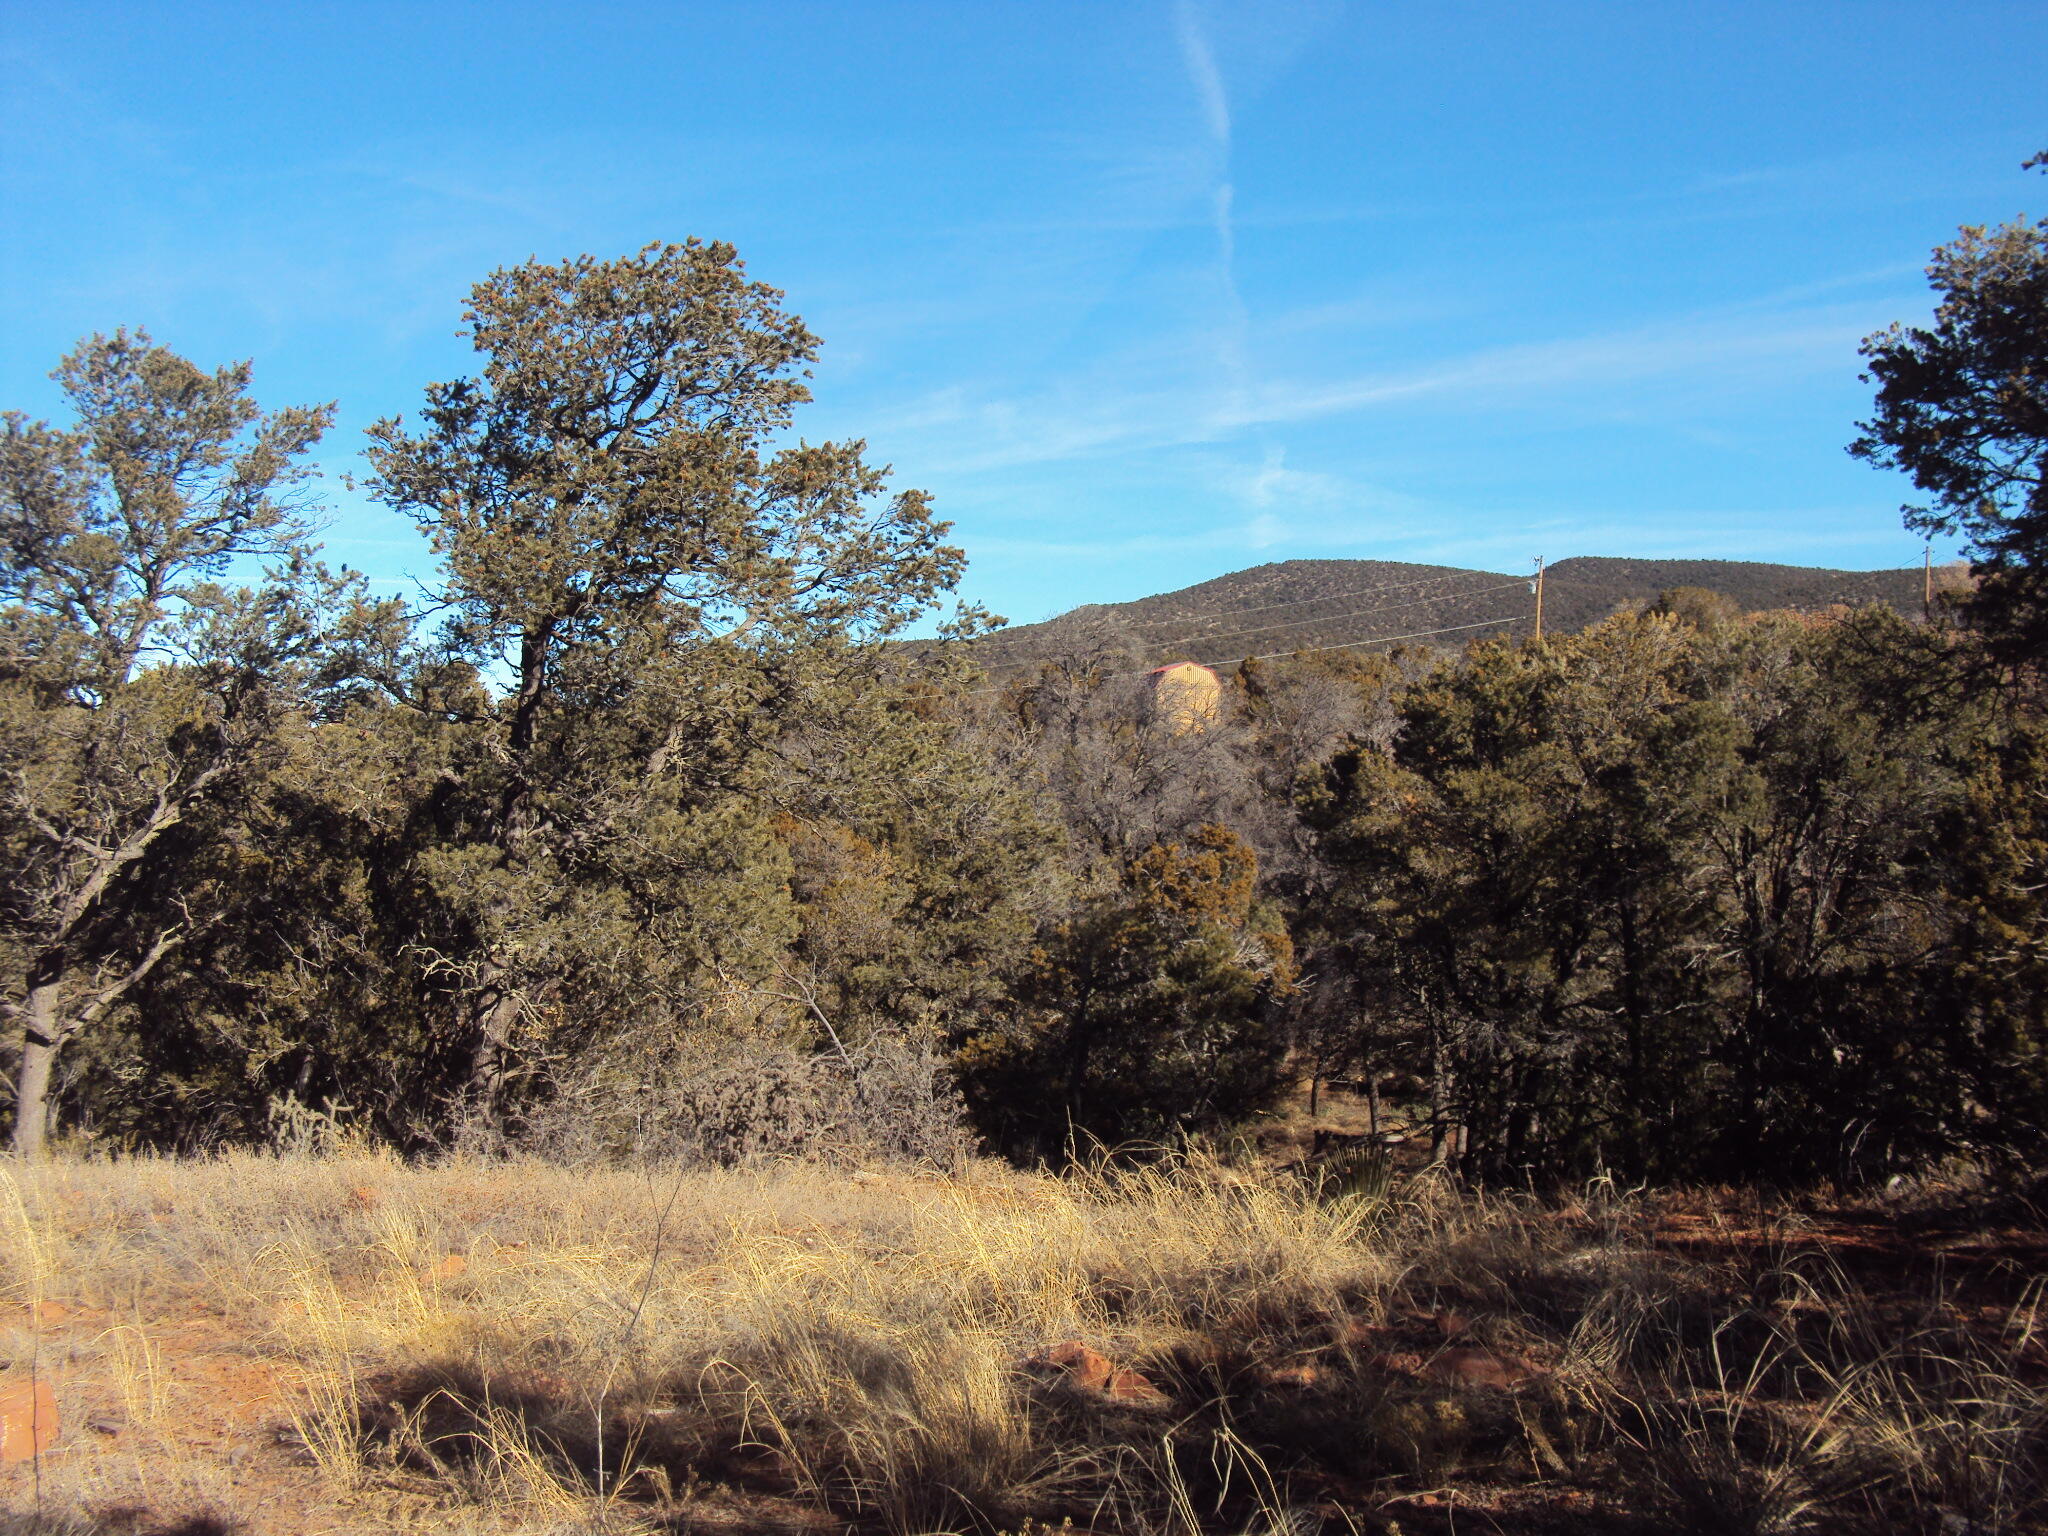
[{"left": 0, "top": 186, "right": 2048, "bottom": 1180}]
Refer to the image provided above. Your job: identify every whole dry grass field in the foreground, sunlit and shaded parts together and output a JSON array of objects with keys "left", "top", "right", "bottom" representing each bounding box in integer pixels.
[{"left": 0, "top": 1155, "right": 2044, "bottom": 1536}]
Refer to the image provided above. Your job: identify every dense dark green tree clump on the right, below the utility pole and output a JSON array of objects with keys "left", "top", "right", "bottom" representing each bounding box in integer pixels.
[{"left": 1305, "top": 600, "right": 2048, "bottom": 1178}]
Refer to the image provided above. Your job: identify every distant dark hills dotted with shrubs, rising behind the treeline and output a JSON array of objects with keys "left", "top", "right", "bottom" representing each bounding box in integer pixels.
[{"left": 977, "top": 557, "right": 1960, "bottom": 668}]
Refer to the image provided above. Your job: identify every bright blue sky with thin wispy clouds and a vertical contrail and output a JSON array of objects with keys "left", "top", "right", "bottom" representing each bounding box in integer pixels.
[{"left": 0, "top": 0, "right": 2048, "bottom": 621}]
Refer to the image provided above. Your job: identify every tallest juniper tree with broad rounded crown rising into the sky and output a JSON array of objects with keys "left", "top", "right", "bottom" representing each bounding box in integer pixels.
[{"left": 369, "top": 240, "right": 963, "bottom": 1110}]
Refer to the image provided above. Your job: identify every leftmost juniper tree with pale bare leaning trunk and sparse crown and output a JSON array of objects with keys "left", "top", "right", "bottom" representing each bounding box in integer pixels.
[{"left": 0, "top": 332, "right": 370, "bottom": 1153}]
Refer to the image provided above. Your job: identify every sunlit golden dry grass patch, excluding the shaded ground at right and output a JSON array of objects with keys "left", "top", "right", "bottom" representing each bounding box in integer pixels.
[{"left": 4, "top": 1155, "right": 1386, "bottom": 1528}]
